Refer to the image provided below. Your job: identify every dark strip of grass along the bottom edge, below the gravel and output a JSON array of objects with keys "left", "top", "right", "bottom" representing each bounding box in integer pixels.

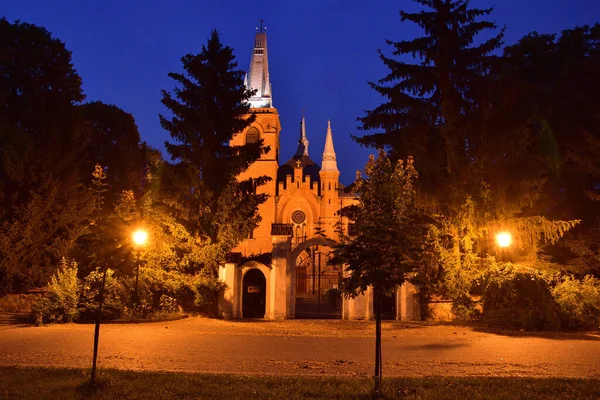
[{"left": 0, "top": 367, "right": 600, "bottom": 400}]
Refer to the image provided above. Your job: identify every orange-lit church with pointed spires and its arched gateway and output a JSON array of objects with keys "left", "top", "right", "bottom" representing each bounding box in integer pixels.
[{"left": 219, "top": 26, "right": 417, "bottom": 320}]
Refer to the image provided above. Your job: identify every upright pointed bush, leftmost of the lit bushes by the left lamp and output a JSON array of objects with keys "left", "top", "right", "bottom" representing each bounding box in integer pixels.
[{"left": 32, "top": 258, "right": 80, "bottom": 325}]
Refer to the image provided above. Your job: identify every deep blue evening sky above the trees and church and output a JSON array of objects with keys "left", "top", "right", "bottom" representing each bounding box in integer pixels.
[{"left": 0, "top": 0, "right": 600, "bottom": 183}]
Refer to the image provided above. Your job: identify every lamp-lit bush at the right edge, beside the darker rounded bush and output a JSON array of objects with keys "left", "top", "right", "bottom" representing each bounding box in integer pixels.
[{"left": 552, "top": 276, "right": 600, "bottom": 329}]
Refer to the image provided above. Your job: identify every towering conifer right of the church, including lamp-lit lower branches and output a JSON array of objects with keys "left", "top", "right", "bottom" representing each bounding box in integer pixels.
[{"left": 356, "top": 0, "right": 577, "bottom": 301}]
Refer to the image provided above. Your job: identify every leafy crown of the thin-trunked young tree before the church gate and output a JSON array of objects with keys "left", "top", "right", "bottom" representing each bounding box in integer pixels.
[{"left": 329, "top": 151, "right": 427, "bottom": 297}]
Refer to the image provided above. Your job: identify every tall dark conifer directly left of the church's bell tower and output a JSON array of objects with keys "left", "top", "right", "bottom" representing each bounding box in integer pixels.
[{"left": 160, "top": 31, "right": 268, "bottom": 276}]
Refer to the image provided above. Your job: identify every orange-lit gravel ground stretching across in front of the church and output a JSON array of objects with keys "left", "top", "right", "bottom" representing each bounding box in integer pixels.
[{"left": 0, "top": 317, "right": 600, "bottom": 378}]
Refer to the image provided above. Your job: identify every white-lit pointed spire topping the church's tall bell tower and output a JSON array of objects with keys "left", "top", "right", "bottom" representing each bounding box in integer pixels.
[{"left": 246, "top": 19, "right": 273, "bottom": 108}]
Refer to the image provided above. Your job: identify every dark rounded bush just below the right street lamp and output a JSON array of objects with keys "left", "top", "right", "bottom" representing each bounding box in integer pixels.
[{"left": 482, "top": 264, "right": 561, "bottom": 330}]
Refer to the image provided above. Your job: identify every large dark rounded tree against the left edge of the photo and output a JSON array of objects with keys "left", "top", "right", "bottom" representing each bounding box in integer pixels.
[{"left": 0, "top": 18, "right": 92, "bottom": 293}]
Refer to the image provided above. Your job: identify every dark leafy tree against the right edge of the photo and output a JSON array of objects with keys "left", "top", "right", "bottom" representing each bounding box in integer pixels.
[{"left": 501, "top": 24, "right": 600, "bottom": 273}]
